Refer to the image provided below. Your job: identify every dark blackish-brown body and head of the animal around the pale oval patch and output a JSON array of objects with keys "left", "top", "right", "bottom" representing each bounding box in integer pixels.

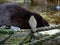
[{"left": 0, "top": 3, "right": 49, "bottom": 29}]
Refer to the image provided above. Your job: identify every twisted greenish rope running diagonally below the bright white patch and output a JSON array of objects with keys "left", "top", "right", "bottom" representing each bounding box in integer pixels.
[{"left": 26, "top": 32, "right": 60, "bottom": 45}]
